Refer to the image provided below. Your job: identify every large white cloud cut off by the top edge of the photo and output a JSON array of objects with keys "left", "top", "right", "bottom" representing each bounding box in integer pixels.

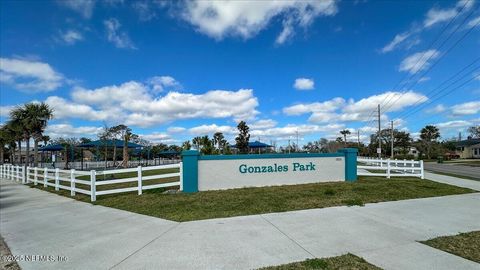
[{"left": 182, "top": 0, "right": 337, "bottom": 44}]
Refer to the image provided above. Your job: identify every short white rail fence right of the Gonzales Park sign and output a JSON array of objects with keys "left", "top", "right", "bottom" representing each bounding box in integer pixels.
[{"left": 357, "top": 157, "right": 424, "bottom": 179}]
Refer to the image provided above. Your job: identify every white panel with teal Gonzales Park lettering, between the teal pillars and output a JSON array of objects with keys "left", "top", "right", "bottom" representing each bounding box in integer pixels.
[{"left": 198, "top": 157, "right": 345, "bottom": 191}]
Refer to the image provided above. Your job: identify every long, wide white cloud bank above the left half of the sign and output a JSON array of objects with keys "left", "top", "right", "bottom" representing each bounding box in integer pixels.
[{"left": 68, "top": 81, "right": 259, "bottom": 127}]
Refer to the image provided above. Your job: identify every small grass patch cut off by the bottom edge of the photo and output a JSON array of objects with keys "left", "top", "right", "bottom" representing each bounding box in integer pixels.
[{"left": 260, "top": 254, "right": 381, "bottom": 270}]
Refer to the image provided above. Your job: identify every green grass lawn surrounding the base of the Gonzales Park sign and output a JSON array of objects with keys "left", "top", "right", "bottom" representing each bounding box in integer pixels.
[{"left": 31, "top": 177, "right": 474, "bottom": 221}]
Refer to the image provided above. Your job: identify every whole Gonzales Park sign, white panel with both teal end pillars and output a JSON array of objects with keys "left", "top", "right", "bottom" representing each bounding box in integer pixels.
[{"left": 182, "top": 148, "right": 357, "bottom": 192}]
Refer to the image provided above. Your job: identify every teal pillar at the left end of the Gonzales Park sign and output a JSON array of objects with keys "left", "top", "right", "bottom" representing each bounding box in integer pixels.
[{"left": 182, "top": 150, "right": 200, "bottom": 193}]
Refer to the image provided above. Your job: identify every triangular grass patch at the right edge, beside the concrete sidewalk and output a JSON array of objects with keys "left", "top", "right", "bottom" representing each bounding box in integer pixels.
[{"left": 421, "top": 231, "right": 480, "bottom": 263}]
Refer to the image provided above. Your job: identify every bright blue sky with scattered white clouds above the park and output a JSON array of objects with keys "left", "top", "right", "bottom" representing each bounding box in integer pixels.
[{"left": 0, "top": 0, "right": 480, "bottom": 145}]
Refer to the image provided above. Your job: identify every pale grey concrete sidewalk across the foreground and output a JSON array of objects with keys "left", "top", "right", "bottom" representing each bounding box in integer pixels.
[{"left": 0, "top": 180, "right": 480, "bottom": 269}]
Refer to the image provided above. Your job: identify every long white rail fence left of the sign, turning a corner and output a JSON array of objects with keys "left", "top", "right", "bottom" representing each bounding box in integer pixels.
[{"left": 0, "top": 163, "right": 183, "bottom": 202}]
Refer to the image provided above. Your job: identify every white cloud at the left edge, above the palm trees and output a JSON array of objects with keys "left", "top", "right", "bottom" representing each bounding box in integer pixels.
[{"left": 0, "top": 58, "right": 64, "bottom": 92}]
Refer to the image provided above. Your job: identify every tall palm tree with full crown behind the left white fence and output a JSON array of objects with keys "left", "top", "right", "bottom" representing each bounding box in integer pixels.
[{"left": 10, "top": 102, "right": 53, "bottom": 166}]
